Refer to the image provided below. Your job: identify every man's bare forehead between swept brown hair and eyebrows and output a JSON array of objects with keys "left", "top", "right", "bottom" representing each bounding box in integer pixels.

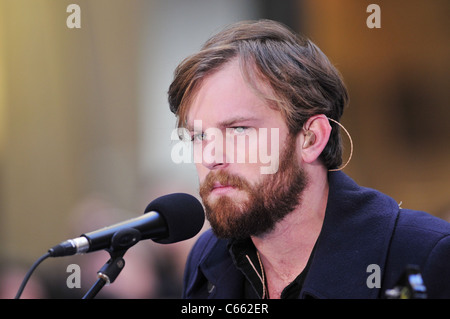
[{"left": 187, "top": 59, "right": 281, "bottom": 128}]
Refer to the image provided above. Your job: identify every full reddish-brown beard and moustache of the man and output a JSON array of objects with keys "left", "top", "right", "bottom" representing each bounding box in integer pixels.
[{"left": 200, "top": 135, "right": 307, "bottom": 239}]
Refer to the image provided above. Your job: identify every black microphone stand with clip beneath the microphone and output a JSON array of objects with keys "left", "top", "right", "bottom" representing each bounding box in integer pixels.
[{"left": 83, "top": 228, "right": 141, "bottom": 299}]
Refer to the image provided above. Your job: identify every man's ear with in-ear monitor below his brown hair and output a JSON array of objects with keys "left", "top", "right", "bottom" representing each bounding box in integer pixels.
[{"left": 299, "top": 114, "right": 331, "bottom": 163}]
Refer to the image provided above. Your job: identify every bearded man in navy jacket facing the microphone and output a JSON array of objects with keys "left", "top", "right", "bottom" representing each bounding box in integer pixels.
[{"left": 169, "top": 20, "right": 450, "bottom": 298}]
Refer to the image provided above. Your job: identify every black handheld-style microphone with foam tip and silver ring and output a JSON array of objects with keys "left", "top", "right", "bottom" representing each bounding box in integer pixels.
[{"left": 48, "top": 193, "right": 205, "bottom": 257}]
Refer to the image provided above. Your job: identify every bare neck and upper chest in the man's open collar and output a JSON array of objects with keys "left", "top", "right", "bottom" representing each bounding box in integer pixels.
[{"left": 252, "top": 166, "right": 328, "bottom": 298}]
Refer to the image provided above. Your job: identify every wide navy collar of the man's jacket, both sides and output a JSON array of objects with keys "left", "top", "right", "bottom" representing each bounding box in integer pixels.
[{"left": 200, "top": 172, "right": 398, "bottom": 299}]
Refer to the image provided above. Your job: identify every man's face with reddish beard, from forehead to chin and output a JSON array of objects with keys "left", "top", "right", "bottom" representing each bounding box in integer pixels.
[{"left": 187, "top": 60, "right": 306, "bottom": 238}]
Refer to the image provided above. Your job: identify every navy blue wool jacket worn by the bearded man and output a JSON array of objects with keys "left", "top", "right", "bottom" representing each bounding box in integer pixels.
[{"left": 183, "top": 172, "right": 450, "bottom": 299}]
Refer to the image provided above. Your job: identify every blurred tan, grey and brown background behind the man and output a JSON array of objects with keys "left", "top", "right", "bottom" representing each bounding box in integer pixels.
[{"left": 0, "top": 0, "right": 450, "bottom": 298}]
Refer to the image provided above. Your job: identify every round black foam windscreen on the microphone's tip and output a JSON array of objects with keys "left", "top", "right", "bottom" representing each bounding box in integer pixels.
[{"left": 145, "top": 193, "right": 205, "bottom": 244}]
